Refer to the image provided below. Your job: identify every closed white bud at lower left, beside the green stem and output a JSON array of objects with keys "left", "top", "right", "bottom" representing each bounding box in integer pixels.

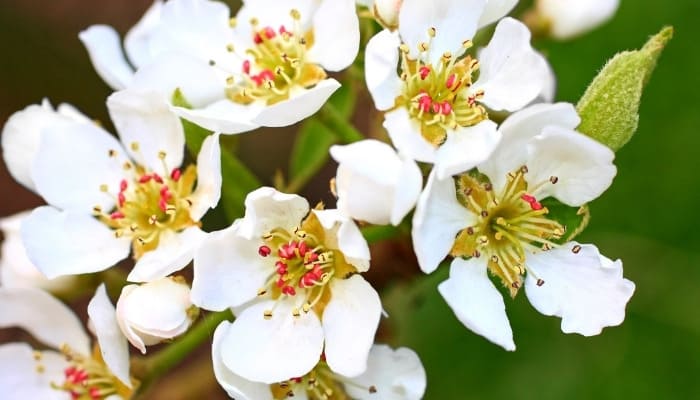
[{"left": 117, "top": 277, "right": 194, "bottom": 354}]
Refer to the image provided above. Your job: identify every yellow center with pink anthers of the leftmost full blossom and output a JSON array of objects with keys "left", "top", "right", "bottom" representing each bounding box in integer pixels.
[{"left": 93, "top": 143, "right": 197, "bottom": 259}]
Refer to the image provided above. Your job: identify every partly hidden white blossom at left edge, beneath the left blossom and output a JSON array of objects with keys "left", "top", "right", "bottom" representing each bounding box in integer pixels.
[{"left": 0, "top": 211, "right": 76, "bottom": 293}]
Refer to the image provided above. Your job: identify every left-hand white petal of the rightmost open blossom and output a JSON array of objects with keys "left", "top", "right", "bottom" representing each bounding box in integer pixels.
[{"left": 411, "top": 171, "right": 476, "bottom": 274}]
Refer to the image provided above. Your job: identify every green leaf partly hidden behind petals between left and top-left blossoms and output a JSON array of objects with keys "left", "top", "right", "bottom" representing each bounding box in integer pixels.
[{"left": 172, "top": 89, "right": 262, "bottom": 222}]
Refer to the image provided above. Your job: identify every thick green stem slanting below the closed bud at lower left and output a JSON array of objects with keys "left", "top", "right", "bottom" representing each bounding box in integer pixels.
[{"left": 133, "top": 310, "right": 233, "bottom": 396}]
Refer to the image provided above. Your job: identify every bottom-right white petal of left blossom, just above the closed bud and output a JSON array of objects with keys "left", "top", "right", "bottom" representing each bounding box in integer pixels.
[{"left": 127, "top": 226, "right": 207, "bottom": 282}]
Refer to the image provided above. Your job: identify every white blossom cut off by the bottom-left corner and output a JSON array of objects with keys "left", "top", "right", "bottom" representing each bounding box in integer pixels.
[{"left": 0, "top": 285, "right": 132, "bottom": 400}]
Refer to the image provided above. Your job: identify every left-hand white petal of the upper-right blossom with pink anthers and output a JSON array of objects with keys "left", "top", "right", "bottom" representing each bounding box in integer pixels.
[{"left": 365, "top": 29, "right": 403, "bottom": 111}]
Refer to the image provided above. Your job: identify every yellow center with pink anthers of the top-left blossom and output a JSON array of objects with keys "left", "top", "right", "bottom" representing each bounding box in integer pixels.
[{"left": 226, "top": 10, "right": 326, "bottom": 105}]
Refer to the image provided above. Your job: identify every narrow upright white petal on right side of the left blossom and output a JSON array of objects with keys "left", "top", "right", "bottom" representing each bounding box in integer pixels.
[{"left": 190, "top": 133, "right": 222, "bottom": 221}]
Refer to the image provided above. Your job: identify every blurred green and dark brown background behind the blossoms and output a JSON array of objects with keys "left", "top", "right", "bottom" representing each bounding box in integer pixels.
[{"left": 0, "top": 0, "right": 700, "bottom": 400}]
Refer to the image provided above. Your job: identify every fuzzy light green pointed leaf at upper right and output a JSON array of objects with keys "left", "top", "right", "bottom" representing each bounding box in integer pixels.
[{"left": 576, "top": 27, "right": 673, "bottom": 151}]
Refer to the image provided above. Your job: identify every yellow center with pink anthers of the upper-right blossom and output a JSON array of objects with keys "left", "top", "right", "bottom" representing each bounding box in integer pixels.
[{"left": 396, "top": 28, "right": 488, "bottom": 146}]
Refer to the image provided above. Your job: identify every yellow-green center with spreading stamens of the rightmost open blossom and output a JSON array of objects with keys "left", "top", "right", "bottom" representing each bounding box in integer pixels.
[{"left": 450, "top": 167, "right": 566, "bottom": 296}]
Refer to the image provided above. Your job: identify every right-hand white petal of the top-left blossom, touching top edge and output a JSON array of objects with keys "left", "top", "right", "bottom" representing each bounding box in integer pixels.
[{"left": 307, "top": 0, "right": 360, "bottom": 71}]
